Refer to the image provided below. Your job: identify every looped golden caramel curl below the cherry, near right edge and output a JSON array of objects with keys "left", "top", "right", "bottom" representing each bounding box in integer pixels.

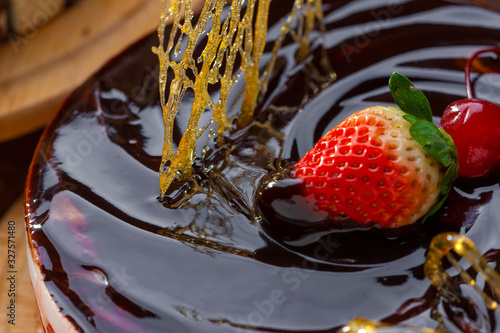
[{"left": 424, "top": 233, "right": 500, "bottom": 310}]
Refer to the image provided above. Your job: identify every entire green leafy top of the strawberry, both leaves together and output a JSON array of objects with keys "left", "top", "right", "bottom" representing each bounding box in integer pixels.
[{"left": 389, "top": 72, "right": 458, "bottom": 222}]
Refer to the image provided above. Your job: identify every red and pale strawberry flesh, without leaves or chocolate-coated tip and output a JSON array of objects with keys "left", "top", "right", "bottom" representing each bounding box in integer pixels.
[{"left": 292, "top": 106, "right": 444, "bottom": 228}]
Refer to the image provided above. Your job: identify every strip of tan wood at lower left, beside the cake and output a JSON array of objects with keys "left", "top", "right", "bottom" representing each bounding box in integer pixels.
[{"left": 0, "top": 197, "right": 43, "bottom": 333}]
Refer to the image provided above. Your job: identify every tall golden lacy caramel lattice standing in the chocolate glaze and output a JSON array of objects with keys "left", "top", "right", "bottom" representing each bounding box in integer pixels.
[{"left": 153, "top": 0, "right": 323, "bottom": 198}]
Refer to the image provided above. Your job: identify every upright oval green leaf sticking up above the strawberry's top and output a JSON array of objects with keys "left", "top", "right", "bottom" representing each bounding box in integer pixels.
[{"left": 389, "top": 72, "right": 432, "bottom": 121}]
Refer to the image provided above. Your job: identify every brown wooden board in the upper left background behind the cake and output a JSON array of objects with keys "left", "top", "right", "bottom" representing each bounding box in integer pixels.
[{"left": 0, "top": 0, "right": 160, "bottom": 142}]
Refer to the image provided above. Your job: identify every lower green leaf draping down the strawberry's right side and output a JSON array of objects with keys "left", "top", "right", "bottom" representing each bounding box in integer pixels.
[{"left": 404, "top": 115, "right": 458, "bottom": 222}]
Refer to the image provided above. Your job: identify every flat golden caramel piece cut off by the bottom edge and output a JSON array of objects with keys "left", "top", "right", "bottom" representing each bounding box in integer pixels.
[{"left": 338, "top": 318, "right": 439, "bottom": 333}]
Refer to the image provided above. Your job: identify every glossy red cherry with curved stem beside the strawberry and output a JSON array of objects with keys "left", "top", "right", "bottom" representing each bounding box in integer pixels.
[{"left": 440, "top": 48, "right": 500, "bottom": 177}]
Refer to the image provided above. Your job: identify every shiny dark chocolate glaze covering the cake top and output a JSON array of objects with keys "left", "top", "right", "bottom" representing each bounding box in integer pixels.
[{"left": 26, "top": 0, "right": 500, "bottom": 332}]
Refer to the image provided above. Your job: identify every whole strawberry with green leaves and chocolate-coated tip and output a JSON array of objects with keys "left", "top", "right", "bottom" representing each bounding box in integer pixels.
[{"left": 256, "top": 72, "right": 458, "bottom": 232}]
